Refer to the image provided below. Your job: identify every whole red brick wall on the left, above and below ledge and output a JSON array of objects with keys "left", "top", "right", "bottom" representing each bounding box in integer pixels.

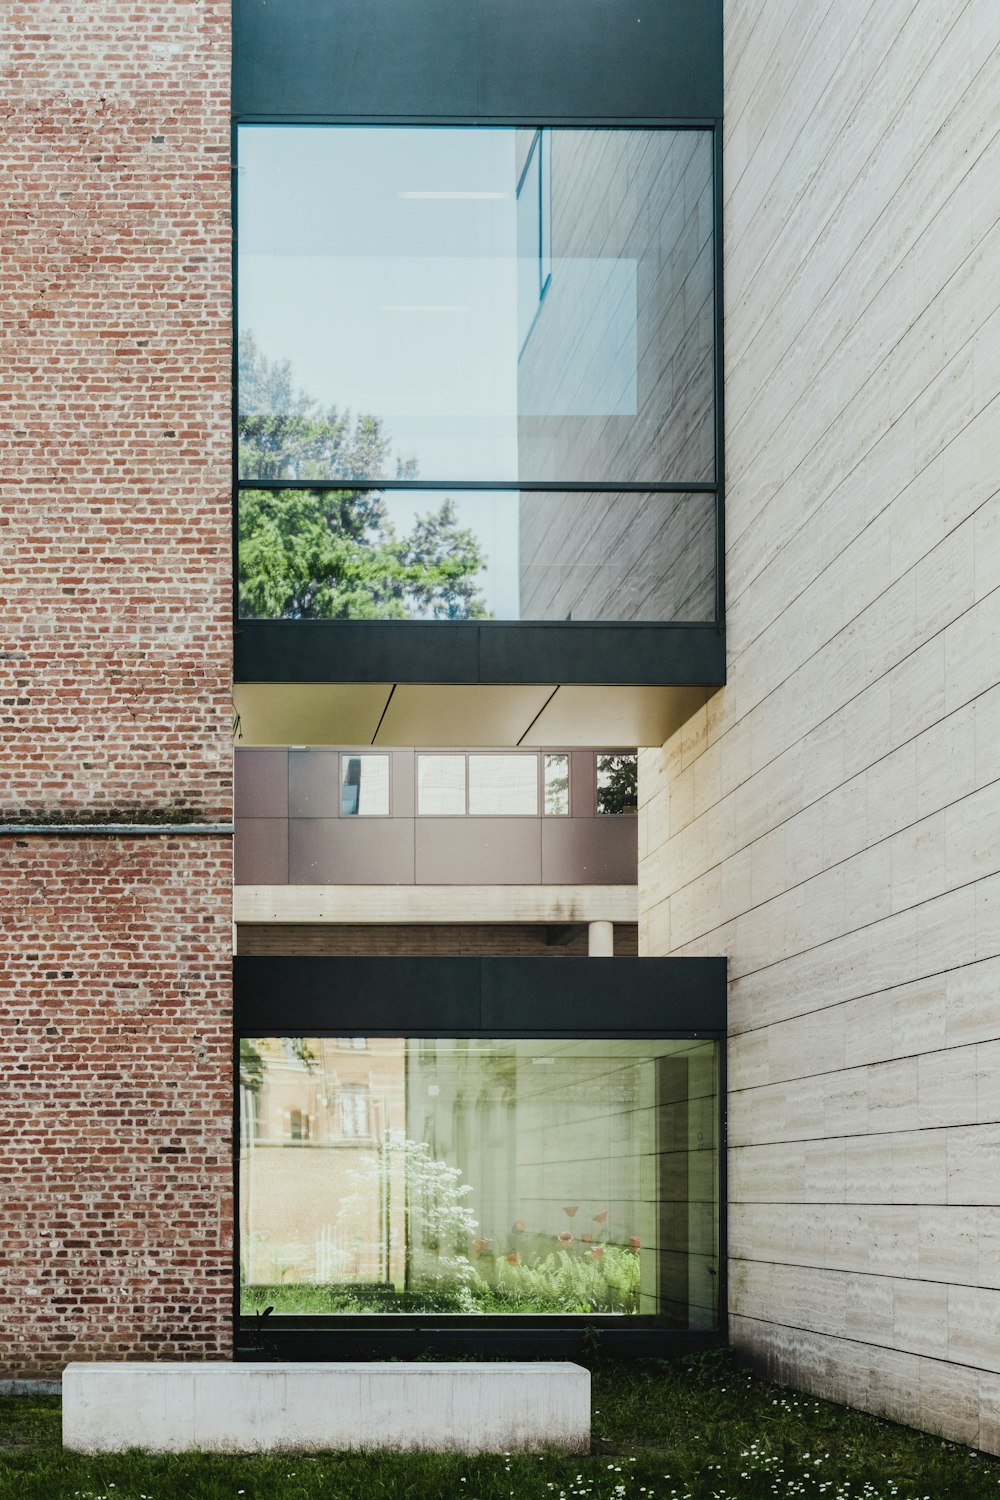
[{"left": 0, "top": 0, "right": 232, "bottom": 1376}]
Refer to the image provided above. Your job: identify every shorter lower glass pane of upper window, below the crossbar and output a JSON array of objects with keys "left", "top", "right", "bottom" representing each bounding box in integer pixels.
[{"left": 240, "top": 489, "right": 715, "bottom": 623}]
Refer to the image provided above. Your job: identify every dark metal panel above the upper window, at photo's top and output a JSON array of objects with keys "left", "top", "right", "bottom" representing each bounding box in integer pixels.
[{"left": 232, "top": 0, "right": 723, "bottom": 122}]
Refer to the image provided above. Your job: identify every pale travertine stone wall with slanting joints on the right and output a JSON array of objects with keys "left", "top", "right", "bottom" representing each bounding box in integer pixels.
[{"left": 640, "top": 0, "right": 1000, "bottom": 1452}]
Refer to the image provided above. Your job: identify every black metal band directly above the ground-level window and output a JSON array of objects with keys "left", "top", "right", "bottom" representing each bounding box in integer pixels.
[{"left": 234, "top": 954, "right": 726, "bottom": 1037}]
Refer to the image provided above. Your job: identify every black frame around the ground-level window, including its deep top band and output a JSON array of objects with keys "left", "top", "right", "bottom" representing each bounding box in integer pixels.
[{"left": 232, "top": 956, "right": 729, "bottom": 1361}]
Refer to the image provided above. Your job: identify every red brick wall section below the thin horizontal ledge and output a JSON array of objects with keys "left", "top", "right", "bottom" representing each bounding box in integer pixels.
[{"left": 0, "top": 834, "right": 232, "bottom": 1376}]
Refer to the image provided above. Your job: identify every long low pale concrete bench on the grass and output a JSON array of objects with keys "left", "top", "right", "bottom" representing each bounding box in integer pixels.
[{"left": 63, "top": 1362, "right": 591, "bottom": 1454}]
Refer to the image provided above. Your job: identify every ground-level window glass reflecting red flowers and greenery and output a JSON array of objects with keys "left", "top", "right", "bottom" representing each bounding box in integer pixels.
[{"left": 240, "top": 1037, "right": 718, "bottom": 1328}]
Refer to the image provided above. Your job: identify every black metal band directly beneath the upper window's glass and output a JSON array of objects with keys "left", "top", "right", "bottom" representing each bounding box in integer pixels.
[{"left": 234, "top": 620, "right": 726, "bottom": 687}]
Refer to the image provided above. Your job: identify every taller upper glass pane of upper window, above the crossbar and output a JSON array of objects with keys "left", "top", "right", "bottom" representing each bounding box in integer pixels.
[{"left": 238, "top": 126, "right": 715, "bottom": 483}]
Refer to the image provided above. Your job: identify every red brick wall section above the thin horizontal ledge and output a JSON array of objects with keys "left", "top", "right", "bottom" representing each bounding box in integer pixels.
[{"left": 0, "top": 0, "right": 231, "bottom": 816}]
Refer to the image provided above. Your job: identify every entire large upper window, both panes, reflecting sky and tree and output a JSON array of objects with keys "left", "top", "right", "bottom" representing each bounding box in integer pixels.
[{"left": 238, "top": 125, "right": 715, "bottom": 623}]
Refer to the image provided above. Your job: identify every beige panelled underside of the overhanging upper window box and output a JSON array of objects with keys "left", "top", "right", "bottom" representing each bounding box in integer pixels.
[{"left": 232, "top": 683, "right": 712, "bottom": 749}]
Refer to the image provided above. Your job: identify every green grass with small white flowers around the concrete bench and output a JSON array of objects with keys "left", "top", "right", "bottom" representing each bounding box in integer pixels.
[{"left": 0, "top": 1358, "right": 1000, "bottom": 1500}]
